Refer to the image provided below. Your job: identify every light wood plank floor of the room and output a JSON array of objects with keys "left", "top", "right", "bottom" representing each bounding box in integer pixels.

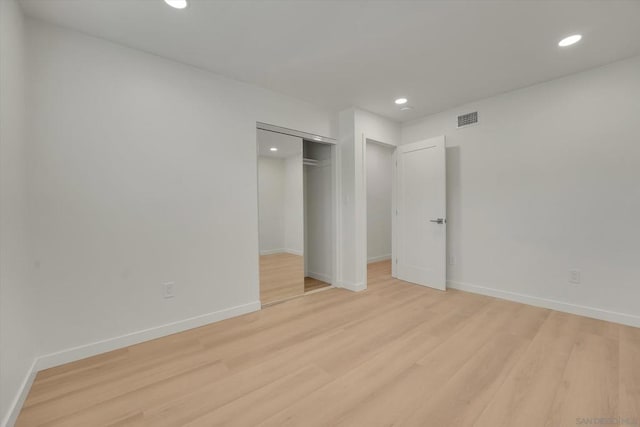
[{"left": 17, "top": 262, "right": 640, "bottom": 427}]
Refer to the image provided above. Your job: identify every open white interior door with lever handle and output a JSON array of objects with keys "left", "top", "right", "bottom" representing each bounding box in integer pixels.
[{"left": 394, "top": 136, "right": 447, "bottom": 290}]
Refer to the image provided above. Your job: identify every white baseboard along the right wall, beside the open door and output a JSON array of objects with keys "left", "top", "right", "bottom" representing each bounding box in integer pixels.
[{"left": 447, "top": 280, "right": 640, "bottom": 327}]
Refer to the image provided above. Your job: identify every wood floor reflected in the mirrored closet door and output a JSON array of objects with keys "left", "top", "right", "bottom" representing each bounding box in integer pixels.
[{"left": 260, "top": 253, "right": 304, "bottom": 305}]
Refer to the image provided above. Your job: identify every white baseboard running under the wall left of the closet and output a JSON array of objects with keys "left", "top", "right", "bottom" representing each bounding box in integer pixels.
[{"left": 36, "top": 301, "right": 260, "bottom": 371}]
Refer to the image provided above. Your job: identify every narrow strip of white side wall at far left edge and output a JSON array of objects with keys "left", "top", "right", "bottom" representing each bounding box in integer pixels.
[{"left": 0, "top": 0, "right": 37, "bottom": 426}]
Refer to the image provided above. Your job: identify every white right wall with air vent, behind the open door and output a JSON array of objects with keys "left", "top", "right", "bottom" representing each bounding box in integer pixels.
[{"left": 402, "top": 57, "right": 640, "bottom": 325}]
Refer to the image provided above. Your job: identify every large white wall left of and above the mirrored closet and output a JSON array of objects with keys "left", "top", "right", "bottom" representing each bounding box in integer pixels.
[{"left": 29, "top": 22, "right": 333, "bottom": 365}]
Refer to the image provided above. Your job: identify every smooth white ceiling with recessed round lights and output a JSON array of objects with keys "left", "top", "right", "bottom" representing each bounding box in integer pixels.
[{"left": 21, "top": 0, "right": 640, "bottom": 121}]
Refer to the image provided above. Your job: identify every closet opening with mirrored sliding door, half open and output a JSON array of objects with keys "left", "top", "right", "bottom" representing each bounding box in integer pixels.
[{"left": 256, "top": 123, "right": 336, "bottom": 306}]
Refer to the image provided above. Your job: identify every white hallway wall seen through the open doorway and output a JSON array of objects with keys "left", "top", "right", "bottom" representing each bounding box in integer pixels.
[{"left": 367, "top": 142, "right": 393, "bottom": 262}]
